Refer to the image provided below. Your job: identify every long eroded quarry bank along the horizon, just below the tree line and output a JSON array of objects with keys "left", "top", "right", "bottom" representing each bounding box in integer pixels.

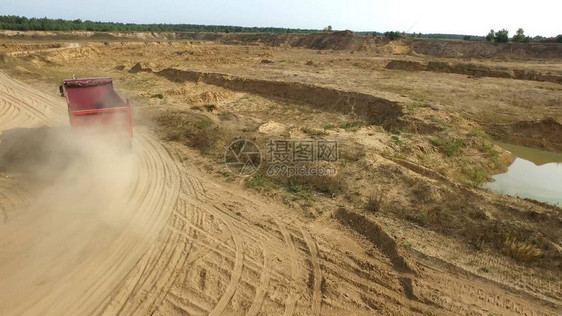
[{"left": 4, "top": 30, "right": 562, "bottom": 59}]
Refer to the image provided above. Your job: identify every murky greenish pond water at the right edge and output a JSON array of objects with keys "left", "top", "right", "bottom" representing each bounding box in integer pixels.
[{"left": 485, "top": 143, "right": 562, "bottom": 205}]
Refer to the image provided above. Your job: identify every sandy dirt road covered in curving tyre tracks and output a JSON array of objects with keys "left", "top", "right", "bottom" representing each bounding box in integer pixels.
[{"left": 0, "top": 74, "right": 557, "bottom": 315}]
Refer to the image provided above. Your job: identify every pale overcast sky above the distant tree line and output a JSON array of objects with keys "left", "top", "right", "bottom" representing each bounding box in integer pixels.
[{"left": 4, "top": 0, "right": 562, "bottom": 36}]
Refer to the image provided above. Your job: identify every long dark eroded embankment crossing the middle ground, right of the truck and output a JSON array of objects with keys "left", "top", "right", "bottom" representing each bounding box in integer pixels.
[{"left": 149, "top": 65, "right": 403, "bottom": 126}]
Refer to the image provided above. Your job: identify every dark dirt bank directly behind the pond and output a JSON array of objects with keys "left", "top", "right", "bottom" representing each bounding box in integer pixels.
[{"left": 488, "top": 118, "right": 562, "bottom": 152}]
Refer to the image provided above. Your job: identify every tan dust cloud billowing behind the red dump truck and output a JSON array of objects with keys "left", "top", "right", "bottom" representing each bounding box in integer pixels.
[{"left": 0, "top": 127, "right": 150, "bottom": 314}]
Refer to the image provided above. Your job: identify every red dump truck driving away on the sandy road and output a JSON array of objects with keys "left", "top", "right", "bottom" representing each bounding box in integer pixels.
[{"left": 60, "top": 77, "right": 133, "bottom": 143}]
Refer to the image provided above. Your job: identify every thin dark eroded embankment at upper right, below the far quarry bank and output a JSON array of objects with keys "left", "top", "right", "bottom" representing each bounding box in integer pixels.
[{"left": 386, "top": 60, "right": 562, "bottom": 83}]
